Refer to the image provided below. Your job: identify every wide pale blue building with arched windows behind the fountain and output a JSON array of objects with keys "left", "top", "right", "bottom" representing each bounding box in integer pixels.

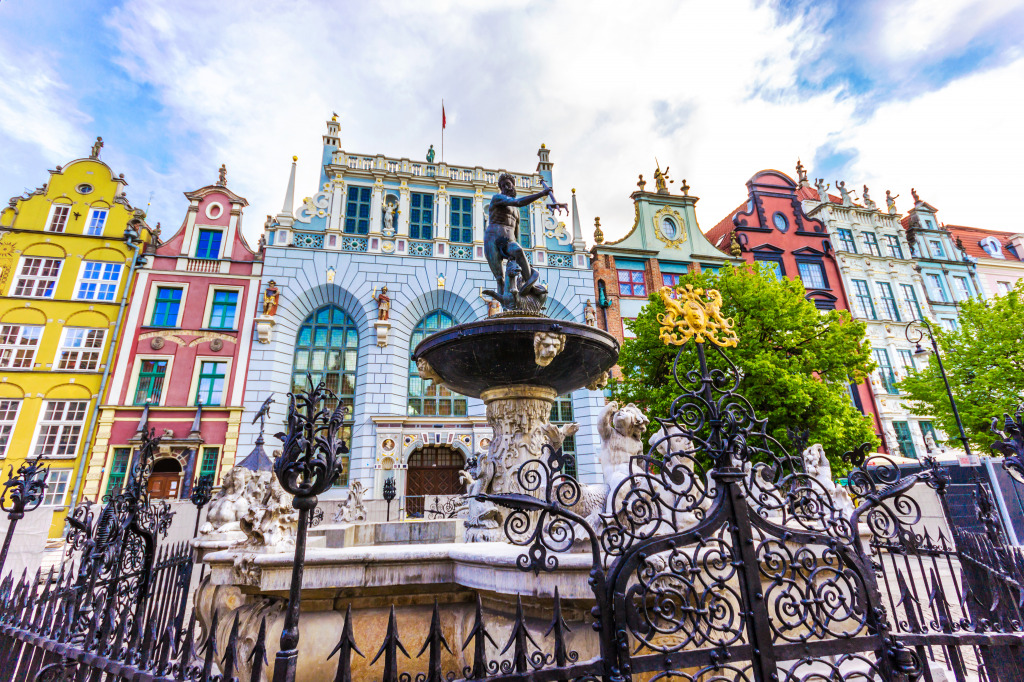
[{"left": 241, "top": 115, "right": 604, "bottom": 498}]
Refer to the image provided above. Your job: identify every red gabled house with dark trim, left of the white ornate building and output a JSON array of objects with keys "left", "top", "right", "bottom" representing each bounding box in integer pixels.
[{"left": 707, "top": 163, "right": 882, "bottom": 434}]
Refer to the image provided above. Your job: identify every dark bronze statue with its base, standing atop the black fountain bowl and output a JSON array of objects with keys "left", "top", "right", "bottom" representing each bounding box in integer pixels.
[{"left": 483, "top": 173, "right": 551, "bottom": 312}]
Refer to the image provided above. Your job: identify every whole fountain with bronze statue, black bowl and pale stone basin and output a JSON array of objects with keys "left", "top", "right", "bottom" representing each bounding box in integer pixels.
[{"left": 197, "top": 165, "right": 618, "bottom": 680}]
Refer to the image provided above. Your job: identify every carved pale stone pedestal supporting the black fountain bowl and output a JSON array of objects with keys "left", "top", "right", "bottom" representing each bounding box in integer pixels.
[{"left": 466, "top": 385, "right": 557, "bottom": 543}]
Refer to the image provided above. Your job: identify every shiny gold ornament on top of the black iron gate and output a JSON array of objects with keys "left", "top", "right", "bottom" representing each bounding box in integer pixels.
[{"left": 657, "top": 285, "right": 739, "bottom": 347}]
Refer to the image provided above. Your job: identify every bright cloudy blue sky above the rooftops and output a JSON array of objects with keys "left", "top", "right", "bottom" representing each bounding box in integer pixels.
[{"left": 0, "top": 0, "right": 1024, "bottom": 244}]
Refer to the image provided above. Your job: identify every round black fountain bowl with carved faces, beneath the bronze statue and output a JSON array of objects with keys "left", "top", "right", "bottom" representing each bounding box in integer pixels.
[{"left": 413, "top": 315, "right": 618, "bottom": 397}]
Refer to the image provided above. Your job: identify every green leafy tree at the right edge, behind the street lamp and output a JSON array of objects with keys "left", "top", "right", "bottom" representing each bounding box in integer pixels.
[{"left": 899, "top": 280, "right": 1024, "bottom": 454}]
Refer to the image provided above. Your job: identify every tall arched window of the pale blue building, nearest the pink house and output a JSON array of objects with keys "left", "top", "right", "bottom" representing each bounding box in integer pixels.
[{"left": 292, "top": 305, "right": 359, "bottom": 485}]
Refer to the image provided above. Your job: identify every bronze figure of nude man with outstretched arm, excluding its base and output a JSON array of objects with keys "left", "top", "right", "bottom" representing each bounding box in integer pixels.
[{"left": 483, "top": 173, "right": 551, "bottom": 296}]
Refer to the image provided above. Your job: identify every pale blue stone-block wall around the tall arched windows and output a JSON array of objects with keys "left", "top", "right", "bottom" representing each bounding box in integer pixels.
[{"left": 239, "top": 247, "right": 604, "bottom": 498}]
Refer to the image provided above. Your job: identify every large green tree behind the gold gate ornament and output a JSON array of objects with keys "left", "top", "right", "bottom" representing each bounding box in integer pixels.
[{"left": 611, "top": 261, "right": 878, "bottom": 475}]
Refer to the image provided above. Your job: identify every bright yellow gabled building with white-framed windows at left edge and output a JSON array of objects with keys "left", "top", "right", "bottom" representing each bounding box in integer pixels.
[{"left": 0, "top": 139, "right": 150, "bottom": 538}]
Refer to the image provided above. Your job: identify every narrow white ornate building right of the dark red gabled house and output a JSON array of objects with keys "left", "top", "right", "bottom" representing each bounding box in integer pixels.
[{"left": 801, "top": 184, "right": 958, "bottom": 458}]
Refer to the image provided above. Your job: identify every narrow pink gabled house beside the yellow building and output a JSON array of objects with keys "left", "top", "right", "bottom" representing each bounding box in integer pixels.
[{"left": 84, "top": 175, "right": 262, "bottom": 500}]
